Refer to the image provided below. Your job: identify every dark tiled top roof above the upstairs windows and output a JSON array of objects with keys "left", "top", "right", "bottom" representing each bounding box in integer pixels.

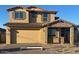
[{"left": 7, "top": 6, "right": 57, "bottom": 14}]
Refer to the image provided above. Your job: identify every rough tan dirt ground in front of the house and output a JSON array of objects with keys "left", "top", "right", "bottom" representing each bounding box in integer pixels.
[{"left": 0, "top": 45, "right": 79, "bottom": 54}]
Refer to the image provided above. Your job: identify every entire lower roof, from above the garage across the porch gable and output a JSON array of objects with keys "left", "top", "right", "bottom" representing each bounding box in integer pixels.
[{"left": 4, "top": 20, "right": 76, "bottom": 28}]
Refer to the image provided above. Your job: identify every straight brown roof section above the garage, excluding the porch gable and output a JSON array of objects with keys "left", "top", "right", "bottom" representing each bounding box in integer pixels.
[{"left": 4, "top": 23, "right": 43, "bottom": 28}]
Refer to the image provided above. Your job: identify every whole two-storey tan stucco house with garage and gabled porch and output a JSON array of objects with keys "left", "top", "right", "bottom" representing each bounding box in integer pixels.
[{"left": 4, "top": 6, "right": 75, "bottom": 45}]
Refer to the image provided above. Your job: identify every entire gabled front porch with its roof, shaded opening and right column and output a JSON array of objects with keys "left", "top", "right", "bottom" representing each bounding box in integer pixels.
[{"left": 48, "top": 20, "right": 75, "bottom": 45}]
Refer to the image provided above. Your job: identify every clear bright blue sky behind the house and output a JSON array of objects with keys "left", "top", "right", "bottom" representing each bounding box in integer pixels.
[{"left": 0, "top": 5, "right": 79, "bottom": 28}]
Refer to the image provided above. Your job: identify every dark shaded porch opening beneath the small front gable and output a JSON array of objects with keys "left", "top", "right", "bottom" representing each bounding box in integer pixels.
[{"left": 48, "top": 28, "right": 70, "bottom": 44}]
